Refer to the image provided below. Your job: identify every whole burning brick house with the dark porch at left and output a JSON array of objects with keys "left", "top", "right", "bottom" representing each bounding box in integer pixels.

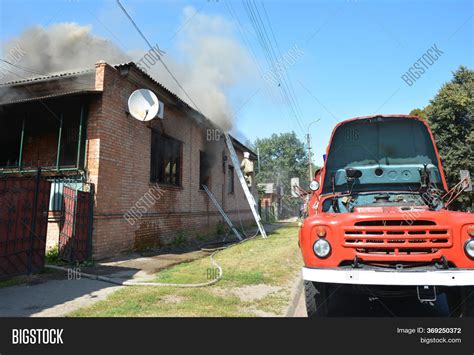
[{"left": 0, "top": 62, "right": 256, "bottom": 259}]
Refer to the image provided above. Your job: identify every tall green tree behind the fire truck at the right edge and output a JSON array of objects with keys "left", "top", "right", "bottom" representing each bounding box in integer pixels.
[{"left": 423, "top": 66, "right": 474, "bottom": 209}]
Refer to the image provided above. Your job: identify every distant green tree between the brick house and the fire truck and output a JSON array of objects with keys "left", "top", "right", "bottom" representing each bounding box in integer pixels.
[{"left": 254, "top": 132, "right": 308, "bottom": 195}]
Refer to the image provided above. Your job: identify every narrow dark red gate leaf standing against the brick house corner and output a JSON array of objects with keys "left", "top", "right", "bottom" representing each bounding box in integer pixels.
[{"left": 59, "top": 185, "right": 94, "bottom": 262}]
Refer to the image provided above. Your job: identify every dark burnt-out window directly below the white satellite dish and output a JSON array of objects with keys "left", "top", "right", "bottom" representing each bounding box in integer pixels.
[{"left": 150, "top": 131, "right": 182, "bottom": 186}]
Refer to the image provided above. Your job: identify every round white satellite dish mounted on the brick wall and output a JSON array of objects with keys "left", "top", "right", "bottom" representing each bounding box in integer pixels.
[{"left": 128, "top": 89, "right": 163, "bottom": 122}]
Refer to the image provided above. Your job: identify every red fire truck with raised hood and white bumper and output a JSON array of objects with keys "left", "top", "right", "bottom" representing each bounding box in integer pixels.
[{"left": 299, "top": 115, "right": 474, "bottom": 316}]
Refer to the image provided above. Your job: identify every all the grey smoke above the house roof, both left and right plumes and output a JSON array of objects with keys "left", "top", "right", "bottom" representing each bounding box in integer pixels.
[{"left": 0, "top": 7, "right": 253, "bottom": 129}]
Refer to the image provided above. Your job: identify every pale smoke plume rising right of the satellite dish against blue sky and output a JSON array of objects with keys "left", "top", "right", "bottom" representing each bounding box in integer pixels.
[{"left": 131, "top": 7, "right": 254, "bottom": 129}]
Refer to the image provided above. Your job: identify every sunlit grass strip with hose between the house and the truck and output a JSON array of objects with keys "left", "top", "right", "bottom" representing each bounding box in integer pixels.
[{"left": 69, "top": 225, "right": 302, "bottom": 317}]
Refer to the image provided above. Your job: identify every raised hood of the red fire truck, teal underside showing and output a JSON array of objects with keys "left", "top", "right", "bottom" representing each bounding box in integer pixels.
[{"left": 322, "top": 117, "right": 443, "bottom": 193}]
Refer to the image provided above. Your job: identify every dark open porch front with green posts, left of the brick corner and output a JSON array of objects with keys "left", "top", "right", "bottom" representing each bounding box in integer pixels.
[{"left": 0, "top": 97, "right": 87, "bottom": 172}]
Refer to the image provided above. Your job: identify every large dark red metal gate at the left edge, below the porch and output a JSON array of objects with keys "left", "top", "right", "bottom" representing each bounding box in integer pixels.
[{"left": 0, "top": 170, "right": 51, "bottom": 278}]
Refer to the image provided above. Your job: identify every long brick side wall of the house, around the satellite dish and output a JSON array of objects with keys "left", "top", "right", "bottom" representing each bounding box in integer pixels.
[{"left": 86, "top": 63, "right": 255, "bottom": 259}]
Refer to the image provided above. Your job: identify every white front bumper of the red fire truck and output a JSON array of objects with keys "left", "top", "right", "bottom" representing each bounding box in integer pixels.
[{"left": 303, "top": 267, "right": 474, "bottom": 286}]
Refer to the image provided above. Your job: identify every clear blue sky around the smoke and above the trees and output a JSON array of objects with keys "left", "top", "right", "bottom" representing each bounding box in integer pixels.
[{"left": 0, "top": 0, "right": 474, "bottom": 165}]
